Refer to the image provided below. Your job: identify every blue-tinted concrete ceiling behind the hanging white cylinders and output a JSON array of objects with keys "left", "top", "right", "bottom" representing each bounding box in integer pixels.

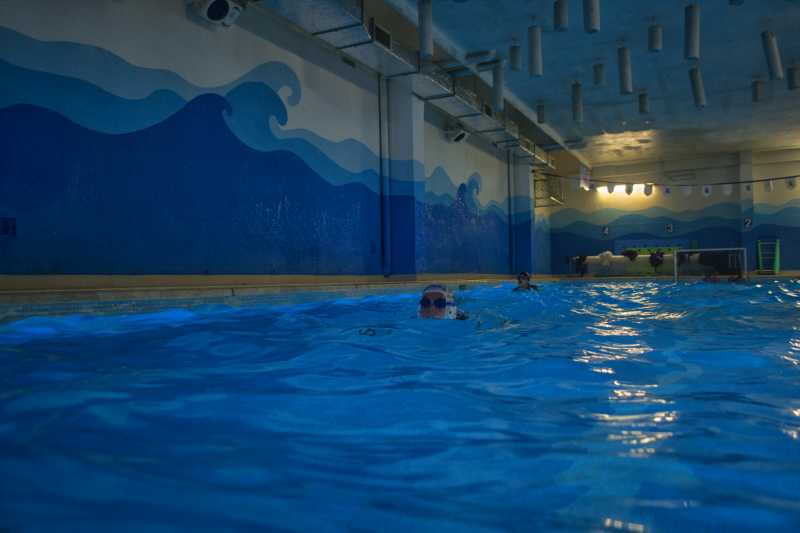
[{"left": 386, "top": 0, "right": 800, "bottom": 165}]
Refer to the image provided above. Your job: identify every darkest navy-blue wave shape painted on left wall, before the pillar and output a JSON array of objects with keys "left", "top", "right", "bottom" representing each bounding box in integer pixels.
[{"left": 0, "top": 95, "right": 380, "bottom": 274}]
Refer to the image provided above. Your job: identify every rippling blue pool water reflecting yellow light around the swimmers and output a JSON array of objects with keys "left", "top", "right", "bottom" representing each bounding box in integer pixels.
[{"left": 0, "top": 280, "right": 800, "bottom": 532}]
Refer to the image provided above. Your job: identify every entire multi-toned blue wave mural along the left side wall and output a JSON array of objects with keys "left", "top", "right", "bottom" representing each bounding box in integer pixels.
[{"left": 0, "top": 29, "right": 520, "bottom": 274}]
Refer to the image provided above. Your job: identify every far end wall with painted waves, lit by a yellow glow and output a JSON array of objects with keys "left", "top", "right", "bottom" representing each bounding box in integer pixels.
[{"left": 549, "top": 151, "right": 800, "bottom": 273}]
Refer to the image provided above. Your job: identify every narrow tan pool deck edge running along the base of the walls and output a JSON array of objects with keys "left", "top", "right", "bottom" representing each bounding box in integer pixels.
[{"left": 0, "top": 271, "right": 800, "bottom": 322}]
